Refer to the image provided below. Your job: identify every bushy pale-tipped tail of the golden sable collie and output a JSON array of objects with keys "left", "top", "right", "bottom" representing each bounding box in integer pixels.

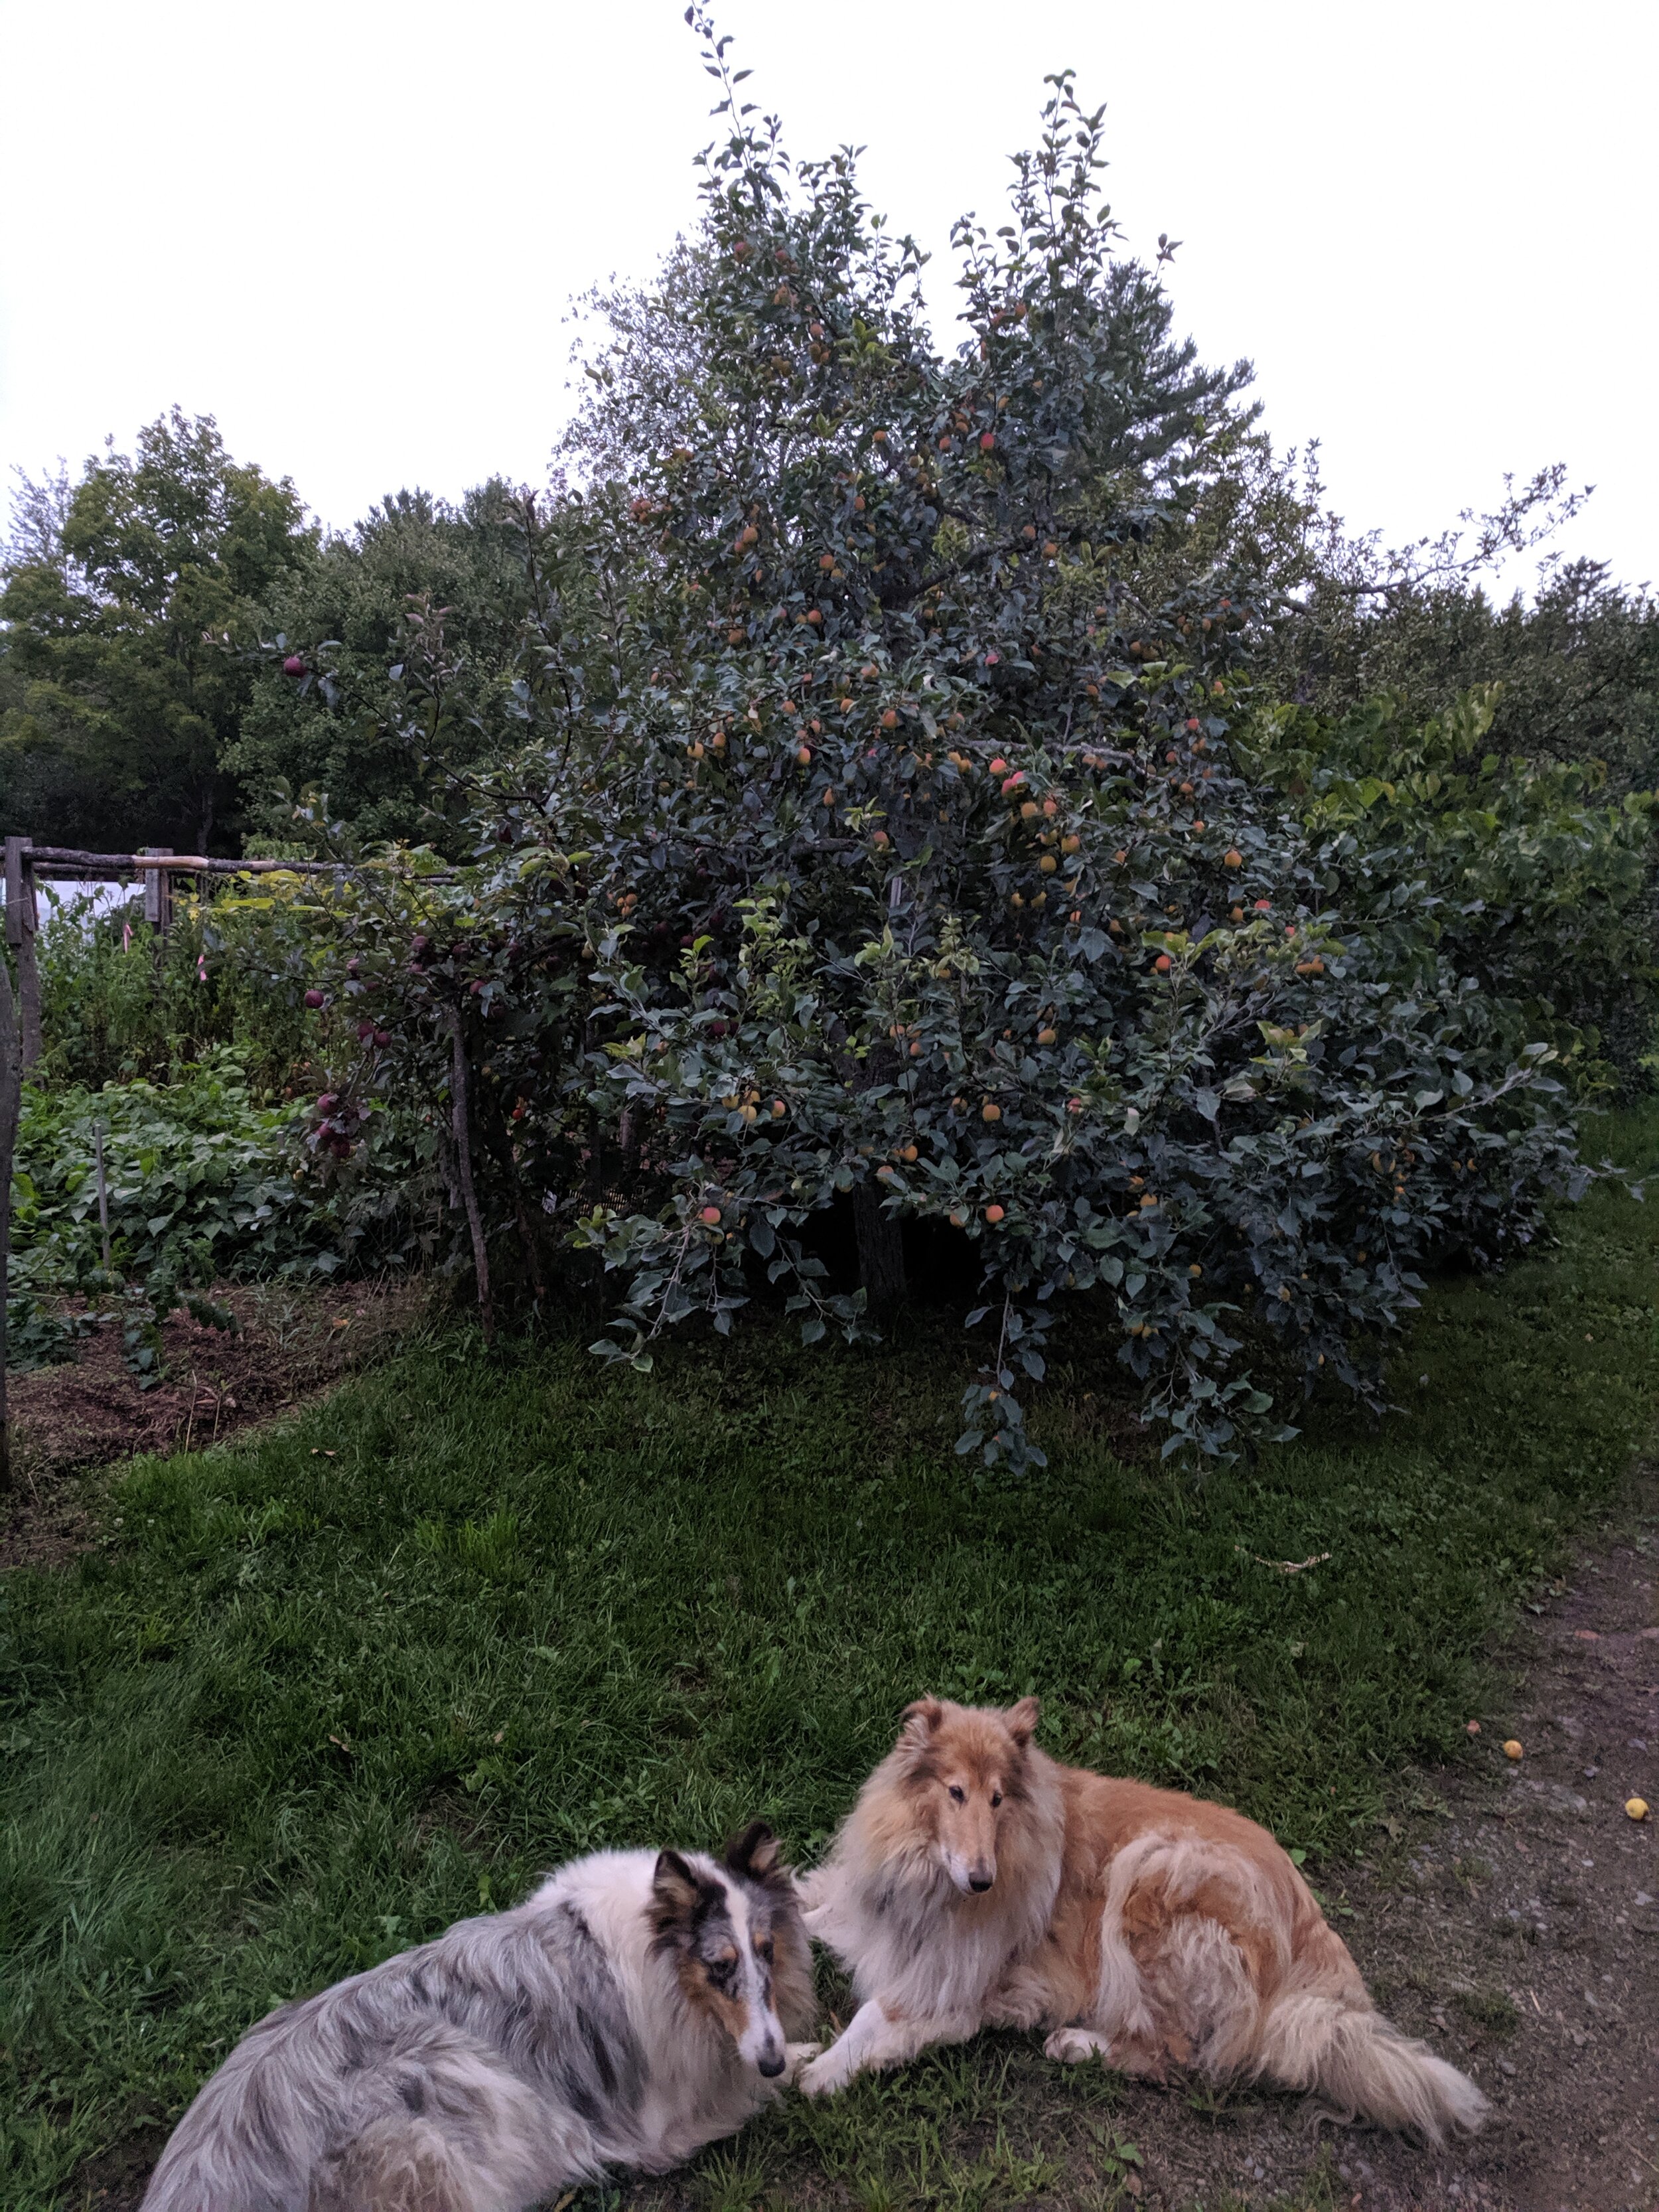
[{"left": 1256, "top": 1995, "right": 1486, "bottom": 2144}]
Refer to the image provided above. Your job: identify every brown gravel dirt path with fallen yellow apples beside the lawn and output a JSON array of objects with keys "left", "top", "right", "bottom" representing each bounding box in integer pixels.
[{"left": 1084, "top": 1469, "right": 1659, "bottom": 2212}]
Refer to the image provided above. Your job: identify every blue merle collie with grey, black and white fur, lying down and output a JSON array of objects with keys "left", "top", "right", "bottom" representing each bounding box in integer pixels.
[{"left": 144, "top": 1820, "right": 818, "bottom": 2212}]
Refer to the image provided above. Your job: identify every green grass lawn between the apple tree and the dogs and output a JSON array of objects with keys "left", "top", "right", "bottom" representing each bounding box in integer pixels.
[{"left": 0, "top": 1112, "right": 1659, "bottom": 2212}]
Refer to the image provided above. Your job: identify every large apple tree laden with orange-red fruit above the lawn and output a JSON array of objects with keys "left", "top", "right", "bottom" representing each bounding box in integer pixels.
[{"left": 234, "top": 30, "right": 1646, "bottom": 1464}]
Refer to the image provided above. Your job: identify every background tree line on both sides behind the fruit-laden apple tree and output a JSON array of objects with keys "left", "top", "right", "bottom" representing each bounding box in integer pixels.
[{"left": 0, "top": 384, "right": 1659, "bottom": 854}]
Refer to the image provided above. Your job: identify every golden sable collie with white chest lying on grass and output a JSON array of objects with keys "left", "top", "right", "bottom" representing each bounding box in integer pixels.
[{"left": 798, "top": 1696, "right": 1486, "bottom": 2141}]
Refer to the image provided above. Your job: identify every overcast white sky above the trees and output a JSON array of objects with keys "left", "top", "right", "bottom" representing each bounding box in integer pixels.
[{"left": 0, "top": 0, "right": 1659, "bottom": 597}]
